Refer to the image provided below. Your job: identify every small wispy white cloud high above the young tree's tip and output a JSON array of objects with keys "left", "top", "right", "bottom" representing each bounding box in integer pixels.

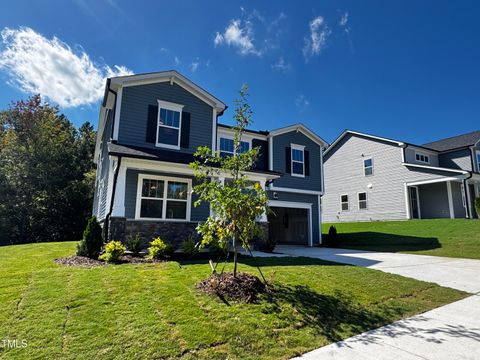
[{"left": 213, "top": 19, "right": 261, "bottom": 56}]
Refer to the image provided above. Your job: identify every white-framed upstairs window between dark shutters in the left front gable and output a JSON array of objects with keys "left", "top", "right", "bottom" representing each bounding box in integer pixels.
[{"left": 155, "top": 100, "right": 183, "bottom": 150}]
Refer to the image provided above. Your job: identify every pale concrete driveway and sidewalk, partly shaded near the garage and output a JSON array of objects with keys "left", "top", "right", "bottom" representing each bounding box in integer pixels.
[{"left": 266, "top": 245, "right": 480, "bottom": 360}]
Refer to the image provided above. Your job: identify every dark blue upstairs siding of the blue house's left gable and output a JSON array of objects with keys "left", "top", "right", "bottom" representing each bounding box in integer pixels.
[{"left": 118, "top": 82, "right": 213, "bottom": 154}]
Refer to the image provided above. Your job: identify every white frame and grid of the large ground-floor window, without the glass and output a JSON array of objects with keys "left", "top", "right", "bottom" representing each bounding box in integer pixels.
[{"left": 135, "top": 174, "right": 192, "bottom": 222}]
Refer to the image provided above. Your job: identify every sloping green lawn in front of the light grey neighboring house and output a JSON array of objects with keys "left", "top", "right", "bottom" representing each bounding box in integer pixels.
[{"left": 323, "top": 219, "right": 480, "bottom": 259}]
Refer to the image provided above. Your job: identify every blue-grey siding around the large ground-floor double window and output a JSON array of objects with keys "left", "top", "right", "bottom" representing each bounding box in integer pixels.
[{"left": 125, "top": 169, "right": 210, "bottom": 221}]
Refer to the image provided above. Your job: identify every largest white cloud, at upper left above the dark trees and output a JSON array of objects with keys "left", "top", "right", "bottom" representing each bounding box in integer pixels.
[{"left": 0, "top": 27, "right": 132, "bottom": 108}]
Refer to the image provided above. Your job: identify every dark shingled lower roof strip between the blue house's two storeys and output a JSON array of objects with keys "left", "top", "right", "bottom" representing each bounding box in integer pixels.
[{"left": 108, "top": 142, "right": 281, "bottom": 175}]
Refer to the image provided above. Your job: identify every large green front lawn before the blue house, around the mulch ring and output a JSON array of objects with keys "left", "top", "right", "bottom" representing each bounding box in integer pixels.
[{"left": 0, "top": 242, "right": 467, "bottom": 359}]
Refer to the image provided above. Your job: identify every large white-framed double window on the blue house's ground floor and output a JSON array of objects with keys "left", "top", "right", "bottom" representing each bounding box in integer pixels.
[{"left": 135, "top": 174, "right": 192, "bottom": 221}]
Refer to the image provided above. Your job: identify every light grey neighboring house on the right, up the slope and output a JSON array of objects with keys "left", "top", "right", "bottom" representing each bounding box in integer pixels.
[{"left": 322, "top": 130, "right": 480, "bottom": 222}]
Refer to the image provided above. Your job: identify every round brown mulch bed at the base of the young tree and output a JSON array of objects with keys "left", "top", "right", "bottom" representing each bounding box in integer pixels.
[{"left": 197, "top": 272, "right": 268, "bottom": 303}]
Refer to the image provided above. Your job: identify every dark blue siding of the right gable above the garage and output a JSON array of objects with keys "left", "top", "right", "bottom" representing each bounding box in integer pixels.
[{"left": 272, "top": 130, "right": 322, "bottom": 191}]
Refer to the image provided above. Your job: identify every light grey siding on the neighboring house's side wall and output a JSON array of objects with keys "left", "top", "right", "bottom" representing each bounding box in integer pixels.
[{"left": 322, "top": 134, "right": 464, "bottom": 222}]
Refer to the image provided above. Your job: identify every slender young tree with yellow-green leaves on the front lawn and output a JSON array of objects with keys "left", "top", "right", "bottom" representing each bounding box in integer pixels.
[{"left": 190, "top": 84, "right": 268, "bottom": 277}]
